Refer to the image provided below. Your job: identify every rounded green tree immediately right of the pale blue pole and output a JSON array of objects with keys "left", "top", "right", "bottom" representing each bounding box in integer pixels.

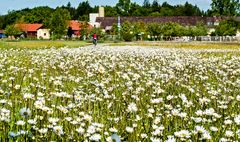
[{"left": 121, "top": 21, "right": 134, "bottom": 41}]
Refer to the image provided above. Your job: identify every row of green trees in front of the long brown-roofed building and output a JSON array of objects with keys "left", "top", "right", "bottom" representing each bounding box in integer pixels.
[{"left": 110, "top": 19, "right": 240, "bottom": 41}]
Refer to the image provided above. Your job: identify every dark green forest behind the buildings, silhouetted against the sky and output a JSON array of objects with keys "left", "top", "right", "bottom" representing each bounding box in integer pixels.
[{"left": 0, "top": 0, "right": 240, "bottom": 29}]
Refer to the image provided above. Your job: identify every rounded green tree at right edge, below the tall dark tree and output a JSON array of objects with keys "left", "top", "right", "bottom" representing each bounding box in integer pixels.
[{"left": 215, "top": 19, "right": 240, "bottom": 36}]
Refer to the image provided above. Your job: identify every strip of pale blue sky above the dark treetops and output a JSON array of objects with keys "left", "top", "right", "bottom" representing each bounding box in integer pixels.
[{"left": 0, "top": 0, "right": 211, "bottom": 15}]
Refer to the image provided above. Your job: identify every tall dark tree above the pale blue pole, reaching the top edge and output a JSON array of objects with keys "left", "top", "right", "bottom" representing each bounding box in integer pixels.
[{"left": 116, "top": 0, "right": 131, "bottom": 16}]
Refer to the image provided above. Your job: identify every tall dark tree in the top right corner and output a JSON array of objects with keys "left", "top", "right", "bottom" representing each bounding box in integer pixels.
[{"left": 211, "top": 0, "right": 240, "bottom": 16}]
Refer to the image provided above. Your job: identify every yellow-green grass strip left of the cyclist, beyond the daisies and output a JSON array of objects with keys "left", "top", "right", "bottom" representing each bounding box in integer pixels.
[{"left": 0, "top": 41, "right": 89, "bottom": 48}]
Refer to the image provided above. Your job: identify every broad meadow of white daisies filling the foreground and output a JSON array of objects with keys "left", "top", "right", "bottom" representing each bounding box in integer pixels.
[{"left": 0, "top": 43, "right": 240, "bottom": 142}]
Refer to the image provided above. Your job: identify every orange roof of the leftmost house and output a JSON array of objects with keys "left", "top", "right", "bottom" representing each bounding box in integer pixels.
[{"left": 15, "top": 24, "right": 43, "bottom": 32}]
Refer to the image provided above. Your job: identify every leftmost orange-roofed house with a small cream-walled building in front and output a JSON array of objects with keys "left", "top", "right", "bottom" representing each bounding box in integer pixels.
[{"left": 15, "top": 24, "right": 50, "bottom": 39}]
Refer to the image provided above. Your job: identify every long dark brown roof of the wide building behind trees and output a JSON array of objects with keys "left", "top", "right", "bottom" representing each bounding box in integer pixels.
[{"left": 96, "top": 16, "right": 238, "bottom": 28}]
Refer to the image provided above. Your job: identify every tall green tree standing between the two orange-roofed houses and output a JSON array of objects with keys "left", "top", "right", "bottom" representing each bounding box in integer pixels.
[{"left": 50, "top": 8, "right": 70, "bottom": 39}]
